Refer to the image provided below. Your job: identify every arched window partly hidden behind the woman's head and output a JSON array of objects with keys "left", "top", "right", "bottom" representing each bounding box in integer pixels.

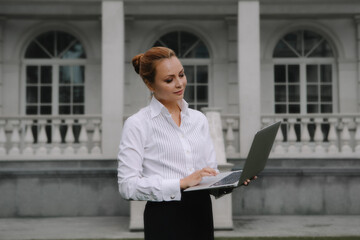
[{"left": 153, "top": 31, "right": 210, "bottom": 110}]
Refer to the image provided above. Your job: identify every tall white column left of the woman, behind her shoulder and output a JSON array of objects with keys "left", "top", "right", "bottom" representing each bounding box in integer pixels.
[{"left": 101, "top": 0, "right": 125, "bottom": 159}]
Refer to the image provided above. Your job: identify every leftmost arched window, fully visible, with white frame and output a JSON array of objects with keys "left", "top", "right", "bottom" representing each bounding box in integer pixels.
[{"left": 24, "top": 31, "right": 86, "bottom": 115}]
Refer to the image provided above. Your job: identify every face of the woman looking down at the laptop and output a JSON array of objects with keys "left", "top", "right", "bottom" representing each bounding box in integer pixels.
[{"left": 148, "top": 57, "right": 187, "bottom": 104}]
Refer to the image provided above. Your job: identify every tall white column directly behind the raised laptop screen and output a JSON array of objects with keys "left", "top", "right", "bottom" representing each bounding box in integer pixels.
[{"left": 238, "top": 0, "right": 261, "bottom": 158}]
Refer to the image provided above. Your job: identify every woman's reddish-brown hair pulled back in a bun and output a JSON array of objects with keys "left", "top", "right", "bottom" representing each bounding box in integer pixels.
[{"left": 132, "top": 47, "right": 176, "bottom": 84}]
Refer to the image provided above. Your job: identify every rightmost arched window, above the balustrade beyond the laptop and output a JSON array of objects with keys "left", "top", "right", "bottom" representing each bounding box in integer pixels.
[{"left": 273, "top": 30, "right": 335, "bottom": 114}]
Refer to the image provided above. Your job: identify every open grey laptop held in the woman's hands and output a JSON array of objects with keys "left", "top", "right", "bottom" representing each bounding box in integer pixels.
[{"left": 184, "top": 121, "right": 281, "bottom": 192}]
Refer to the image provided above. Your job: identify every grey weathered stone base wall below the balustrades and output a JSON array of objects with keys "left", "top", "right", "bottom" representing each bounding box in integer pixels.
[{"left": 0, "top": 159, "right": 360, "bottom": 217}]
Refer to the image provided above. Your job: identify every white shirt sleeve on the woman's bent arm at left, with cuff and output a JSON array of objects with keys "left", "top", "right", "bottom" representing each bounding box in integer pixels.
[{"left": 117, "top": 117, "right": 181, "bottom": 201}]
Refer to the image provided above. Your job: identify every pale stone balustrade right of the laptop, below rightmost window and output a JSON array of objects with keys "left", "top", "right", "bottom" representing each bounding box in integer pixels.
[{"left": 262, "top": 114, "right": 360, "bottom": 158}]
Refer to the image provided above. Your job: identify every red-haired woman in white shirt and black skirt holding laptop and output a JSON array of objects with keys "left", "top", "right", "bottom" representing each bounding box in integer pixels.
[{"left": 118, "top": 47, "right": 252, "bottom": 240}]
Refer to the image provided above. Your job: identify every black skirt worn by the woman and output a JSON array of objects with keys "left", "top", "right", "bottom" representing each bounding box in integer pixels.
[{"left": 144, "top": 191, "right": 214, "bottom": 240}]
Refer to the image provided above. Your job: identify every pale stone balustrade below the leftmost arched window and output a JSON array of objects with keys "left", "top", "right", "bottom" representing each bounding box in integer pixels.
[{"left": 0, "top": 115, "right": 101, "bottom": 160}]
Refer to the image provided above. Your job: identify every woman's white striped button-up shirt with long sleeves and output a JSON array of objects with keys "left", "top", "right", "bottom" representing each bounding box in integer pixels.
[{"left": 118, "top": 97, "right": 217, "bottom": 201}]
